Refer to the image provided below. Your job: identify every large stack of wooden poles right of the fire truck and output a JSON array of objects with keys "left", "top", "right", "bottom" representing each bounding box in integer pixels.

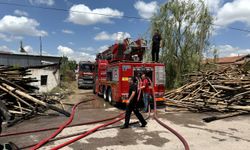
[{"left": 165, "top": 66, "right": 250, "bottom": 122}]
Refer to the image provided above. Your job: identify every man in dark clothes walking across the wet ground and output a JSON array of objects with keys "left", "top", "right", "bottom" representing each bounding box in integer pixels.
[{"left": 121, "top": 77, "right": 147, "bottom": 129}]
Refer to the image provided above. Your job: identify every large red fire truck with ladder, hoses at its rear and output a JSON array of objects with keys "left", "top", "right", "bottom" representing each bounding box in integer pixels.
[{"left": 93, "top": 39, "right": 165, "bottom": 104}]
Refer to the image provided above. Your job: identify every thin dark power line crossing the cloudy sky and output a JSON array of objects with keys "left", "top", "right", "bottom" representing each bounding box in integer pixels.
[{"left": 0, "top": 2, "right": 250, "bottom": 33}]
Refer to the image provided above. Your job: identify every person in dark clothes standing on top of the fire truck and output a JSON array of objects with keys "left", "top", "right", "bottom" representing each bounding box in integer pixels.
[{"left": 152, "top": 30, "right": 161, "bottom": 62}]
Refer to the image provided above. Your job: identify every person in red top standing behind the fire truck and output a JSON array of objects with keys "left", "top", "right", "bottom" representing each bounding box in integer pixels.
[{"left": 141, "top": 73, "right": 150, "bottom": 112}]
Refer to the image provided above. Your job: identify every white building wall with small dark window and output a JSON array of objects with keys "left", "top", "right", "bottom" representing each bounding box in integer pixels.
[{"left": 27, "top": 69, "right": 60, "bottom": 93}]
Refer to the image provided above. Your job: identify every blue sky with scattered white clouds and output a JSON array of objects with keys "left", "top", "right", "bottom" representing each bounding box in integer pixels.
[{"left": 0, "top": 0, "right": 250, "bottom": 61}]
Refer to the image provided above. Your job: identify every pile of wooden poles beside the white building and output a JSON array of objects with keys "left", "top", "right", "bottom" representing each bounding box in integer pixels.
[{"left": 0, "top": 66, "right": 70, "bottom": 125}]
